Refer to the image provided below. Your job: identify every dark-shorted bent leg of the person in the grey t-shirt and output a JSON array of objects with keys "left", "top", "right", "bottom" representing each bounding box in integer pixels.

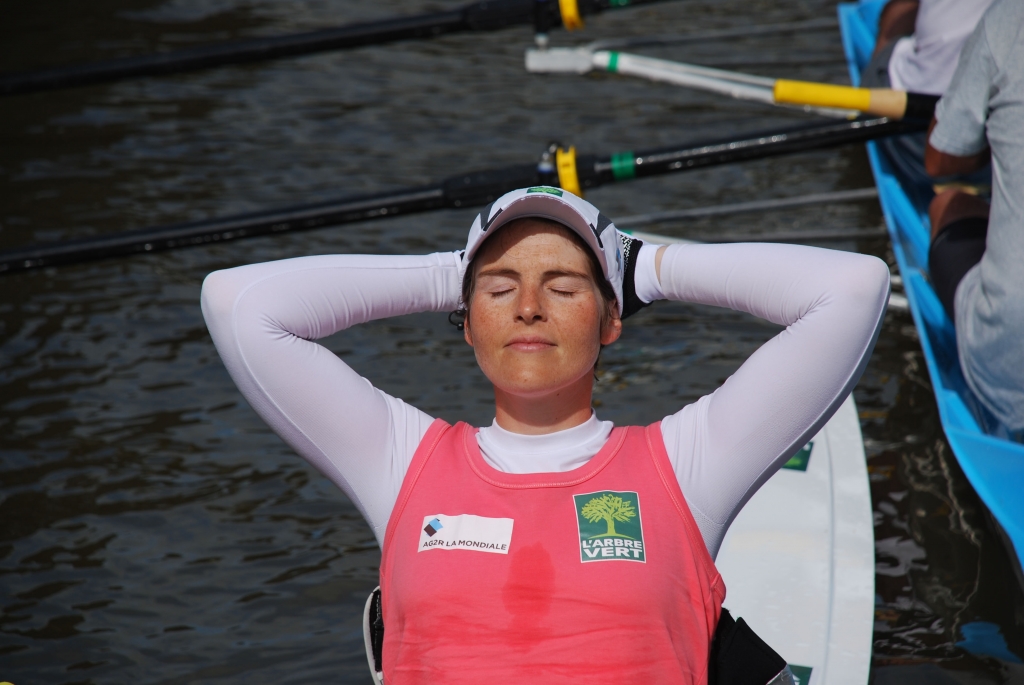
[{"left": 928, "top": 190, "right": 988, "bottom": 322}]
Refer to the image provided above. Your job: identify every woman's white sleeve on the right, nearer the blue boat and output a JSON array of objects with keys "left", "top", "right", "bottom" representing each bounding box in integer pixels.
[{"left": 660, "top": 244, "right": 889, "bottom": 558}]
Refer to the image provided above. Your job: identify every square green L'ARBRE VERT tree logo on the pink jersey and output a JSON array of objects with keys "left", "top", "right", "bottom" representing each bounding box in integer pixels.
[{"left": 572, "top": 490, "right": 647, "bottom": 563}]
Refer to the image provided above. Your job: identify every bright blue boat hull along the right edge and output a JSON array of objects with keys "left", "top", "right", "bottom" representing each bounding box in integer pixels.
[{"left": 839, "top": 0, "right": 1024, "bottom": 574}]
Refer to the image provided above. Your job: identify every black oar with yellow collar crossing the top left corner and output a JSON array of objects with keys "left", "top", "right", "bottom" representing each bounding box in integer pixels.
[{"left": 0, "top": 0, "right": 662, "bottom": 95}]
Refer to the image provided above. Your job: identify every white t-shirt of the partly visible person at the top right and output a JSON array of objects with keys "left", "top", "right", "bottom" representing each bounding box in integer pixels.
[{"left": 889, "top": 0, "right": 993, "bottom": 95}]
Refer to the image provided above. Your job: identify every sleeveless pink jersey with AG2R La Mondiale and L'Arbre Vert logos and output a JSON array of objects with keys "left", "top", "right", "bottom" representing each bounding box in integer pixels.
[{"left": 381, "top": 420, "right": 725, "bottom": 685}]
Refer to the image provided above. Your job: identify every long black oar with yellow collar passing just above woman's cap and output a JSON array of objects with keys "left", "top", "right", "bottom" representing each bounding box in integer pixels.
[{"left": 0, "top": 117, "right": 924, "bottom": 273}]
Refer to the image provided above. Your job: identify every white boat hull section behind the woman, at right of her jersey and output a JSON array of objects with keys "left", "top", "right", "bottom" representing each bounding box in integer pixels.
[{"left": 716, "top": 397, "right": 874, "bottom": 685}]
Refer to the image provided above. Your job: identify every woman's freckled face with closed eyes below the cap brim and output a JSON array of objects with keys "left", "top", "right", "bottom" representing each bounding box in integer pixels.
[{"left": 465, "top": 220, "right": 622, "bottom": 397}]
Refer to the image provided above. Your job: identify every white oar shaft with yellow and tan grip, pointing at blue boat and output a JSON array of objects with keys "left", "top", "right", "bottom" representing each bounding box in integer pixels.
[{"left": 526, "top": 46, "right": 939, "bottom": 121}]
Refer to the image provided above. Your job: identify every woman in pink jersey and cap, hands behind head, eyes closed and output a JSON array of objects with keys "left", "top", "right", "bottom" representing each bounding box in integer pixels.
[{"left": 203, "top": 187, "right": 889, "bottom": 685}]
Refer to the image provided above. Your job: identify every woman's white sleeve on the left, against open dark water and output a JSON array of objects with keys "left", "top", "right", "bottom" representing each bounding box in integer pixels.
[{"left": 203, "top": 253, "right": 460, "bottom": 544}]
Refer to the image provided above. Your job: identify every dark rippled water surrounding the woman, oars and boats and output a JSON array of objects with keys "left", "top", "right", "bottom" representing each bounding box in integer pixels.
[{"left": 0, "top": 0, "right": 1024, "bottom": 685}]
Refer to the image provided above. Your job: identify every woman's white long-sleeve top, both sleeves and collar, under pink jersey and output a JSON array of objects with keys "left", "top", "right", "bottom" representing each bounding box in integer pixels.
[{"left": 203, "top": 244, "right": 889, "bottom": 557}]
